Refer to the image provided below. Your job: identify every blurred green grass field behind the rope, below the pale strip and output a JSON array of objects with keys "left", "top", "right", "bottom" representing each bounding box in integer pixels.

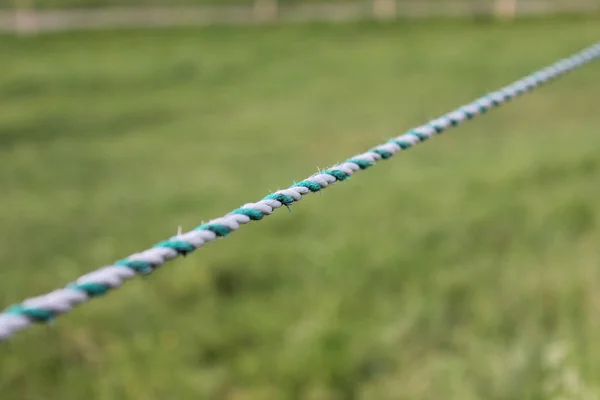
[{"left": 0, "top": 19, "right": 600, "bottom": 400}]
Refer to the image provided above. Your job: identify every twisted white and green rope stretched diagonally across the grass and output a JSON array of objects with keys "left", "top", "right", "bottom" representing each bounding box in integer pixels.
[{"left": 0, "top": 42, "right": 600, "bottom": 342}]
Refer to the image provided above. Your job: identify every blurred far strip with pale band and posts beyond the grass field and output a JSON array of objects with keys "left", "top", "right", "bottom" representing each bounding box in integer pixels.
[{"left": 0, "top": 0, "right": 600, "bottom": 33}]
